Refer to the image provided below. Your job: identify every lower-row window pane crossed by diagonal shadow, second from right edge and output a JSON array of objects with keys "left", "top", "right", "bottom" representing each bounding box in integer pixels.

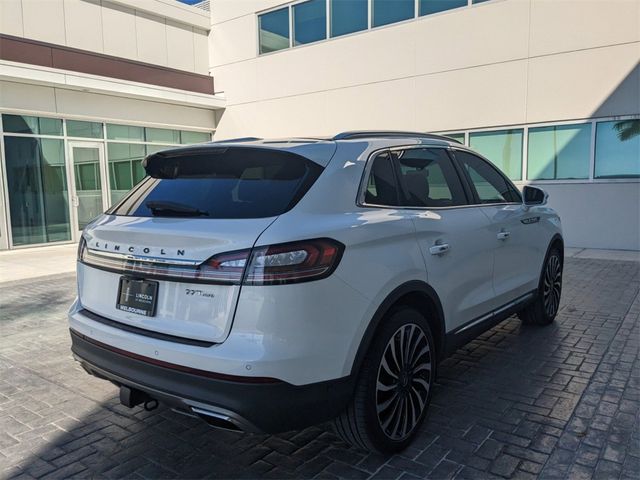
[{"left": 527, "top": 123, "right": 591, "bottom": 180}]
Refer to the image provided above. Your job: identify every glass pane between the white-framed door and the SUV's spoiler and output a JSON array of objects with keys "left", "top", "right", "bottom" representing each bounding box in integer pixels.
[{"left": 107, "top": 143, "right": 145, "bottom": 205}]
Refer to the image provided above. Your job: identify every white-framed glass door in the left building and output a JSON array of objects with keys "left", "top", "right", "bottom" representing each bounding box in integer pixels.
[{"left": 69, "top": 141, "right": 109, "bottom": 236}]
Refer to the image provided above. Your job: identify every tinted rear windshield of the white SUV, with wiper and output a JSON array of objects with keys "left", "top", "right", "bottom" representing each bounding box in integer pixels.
[{"left": 107, "top": 147, "right": 323, "bottom": 218}]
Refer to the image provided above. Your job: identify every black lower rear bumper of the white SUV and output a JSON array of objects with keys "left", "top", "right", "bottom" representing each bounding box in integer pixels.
[{"left": 70, "top": 330, "right": 354, "bottom": 433}]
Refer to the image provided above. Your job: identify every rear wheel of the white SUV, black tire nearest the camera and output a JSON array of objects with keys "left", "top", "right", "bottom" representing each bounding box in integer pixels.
[{"left": 334, "top": 306, "right": 436, "bottom": 453}]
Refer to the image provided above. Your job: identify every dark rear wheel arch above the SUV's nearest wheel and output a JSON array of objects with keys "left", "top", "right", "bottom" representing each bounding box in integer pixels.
[{"left": 351, "top": 280, "right": 446, "bottom": 375}]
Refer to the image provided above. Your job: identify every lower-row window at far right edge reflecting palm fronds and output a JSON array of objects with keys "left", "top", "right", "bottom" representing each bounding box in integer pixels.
[{"left": 594, "top": 119, "right": 640, "bottom": 178}]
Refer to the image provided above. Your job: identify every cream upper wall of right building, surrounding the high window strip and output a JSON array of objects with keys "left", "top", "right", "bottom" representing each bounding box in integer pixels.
[{"left": 210, "top": 0, "right": 640, "bottom": 138}]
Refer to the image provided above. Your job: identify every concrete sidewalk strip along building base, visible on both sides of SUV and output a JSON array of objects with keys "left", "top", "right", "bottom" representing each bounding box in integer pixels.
[{"left": 0, "top": 244, "right": 640, "bottom": 283}]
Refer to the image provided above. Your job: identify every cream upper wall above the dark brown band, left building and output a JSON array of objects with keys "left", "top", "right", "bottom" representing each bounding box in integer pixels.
[{"left": 0, "top": 0, "right": 210, "bottom": 74}]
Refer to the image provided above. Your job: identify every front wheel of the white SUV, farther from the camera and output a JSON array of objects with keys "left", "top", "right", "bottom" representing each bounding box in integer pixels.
[{"left": 518, "top": 247, "right": 562, "bottom": 325}]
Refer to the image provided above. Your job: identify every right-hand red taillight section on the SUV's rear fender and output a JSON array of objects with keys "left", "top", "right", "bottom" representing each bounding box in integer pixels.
[{"left": 244, "top": 238, "right": 344, "bottom": 285}]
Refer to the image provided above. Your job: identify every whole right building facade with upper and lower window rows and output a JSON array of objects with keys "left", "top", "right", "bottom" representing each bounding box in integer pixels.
[{"left": 210, "top": 0, "right": 640, "bottom": 250}]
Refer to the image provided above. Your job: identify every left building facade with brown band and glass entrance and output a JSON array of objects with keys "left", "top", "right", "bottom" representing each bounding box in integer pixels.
[{"left": 0, "top": 0, "right": 225, "bottom": 250}]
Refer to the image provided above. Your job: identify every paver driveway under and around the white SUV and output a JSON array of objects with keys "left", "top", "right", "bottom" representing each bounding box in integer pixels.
[{"left": 0, "top": 258, "right": 640, "bottom": 479}]
